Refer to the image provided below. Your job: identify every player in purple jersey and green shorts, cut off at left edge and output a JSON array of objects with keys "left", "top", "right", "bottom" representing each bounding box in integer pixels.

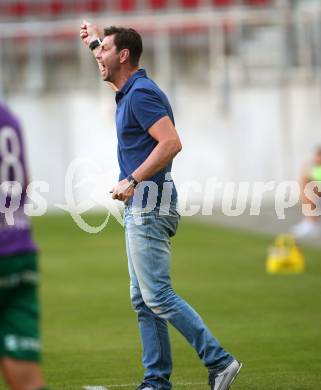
[{"left": 0, "top": 104, "right": 45, "bottom": 390}]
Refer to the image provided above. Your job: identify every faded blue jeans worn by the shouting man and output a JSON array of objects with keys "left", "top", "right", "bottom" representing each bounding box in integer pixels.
[{"left": 124, "top": 204, "right": 233, "bottom": 390}]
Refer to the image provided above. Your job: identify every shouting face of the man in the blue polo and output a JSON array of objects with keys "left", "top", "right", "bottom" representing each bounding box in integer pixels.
[{"left": 96, "top": 35, "right": 120, "bottom": 83}]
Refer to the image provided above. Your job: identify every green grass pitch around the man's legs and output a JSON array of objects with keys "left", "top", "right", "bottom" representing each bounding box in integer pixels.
[{"left": 0, "top": 216, "right": 321, "bottom": 390}]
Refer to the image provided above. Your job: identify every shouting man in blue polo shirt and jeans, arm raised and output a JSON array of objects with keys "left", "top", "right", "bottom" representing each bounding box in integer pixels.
[{"left": 80, "top": 22, "right": 241, "bottom": 390}]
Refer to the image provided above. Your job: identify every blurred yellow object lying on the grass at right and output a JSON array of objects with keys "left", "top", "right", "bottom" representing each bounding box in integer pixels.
[{"left": 266, "top": 234, "right": 304, "bottom": 274}]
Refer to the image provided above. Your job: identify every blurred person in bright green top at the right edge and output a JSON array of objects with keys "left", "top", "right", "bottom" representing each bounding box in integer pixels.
[{"left": 292, "top": 146, "right": 321, "bottom": 238}]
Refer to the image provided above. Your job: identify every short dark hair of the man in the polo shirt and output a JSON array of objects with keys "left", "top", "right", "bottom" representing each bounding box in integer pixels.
[{"left": 104, "top": 26, "right": 143, "bottom": 66}]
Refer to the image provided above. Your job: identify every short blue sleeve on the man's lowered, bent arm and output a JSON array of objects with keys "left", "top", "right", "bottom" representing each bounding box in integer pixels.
[{"left": 131, "top": 89, "right": 168, "bottom": 131}]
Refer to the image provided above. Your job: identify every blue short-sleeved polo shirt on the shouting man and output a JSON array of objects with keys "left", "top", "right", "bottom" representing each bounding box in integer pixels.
[{"left": 116, "top": 69, "right": 177, "bottom": 207}]
